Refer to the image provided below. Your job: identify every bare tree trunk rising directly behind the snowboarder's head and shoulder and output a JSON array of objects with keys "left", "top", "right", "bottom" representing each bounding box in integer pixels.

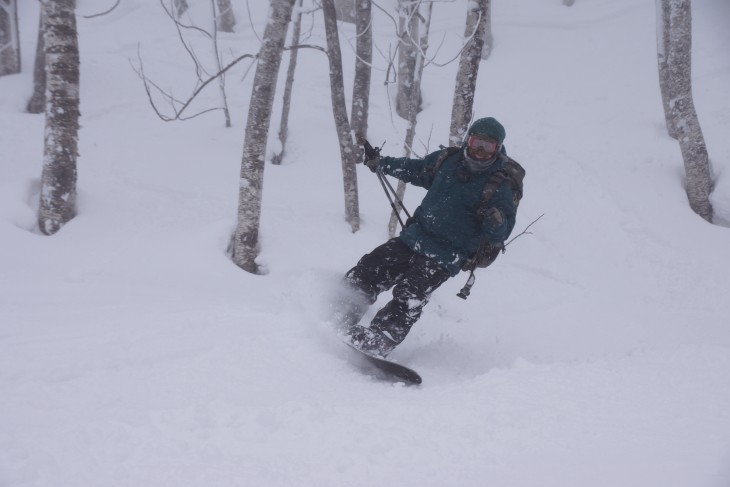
[{"left": 449, "top": 0, "right": 488, "bottom": 145}]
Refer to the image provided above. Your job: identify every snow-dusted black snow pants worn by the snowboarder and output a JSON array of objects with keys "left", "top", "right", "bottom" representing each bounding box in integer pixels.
[{"left": 343, "top": 237, "right": 451, "bottom": 344}]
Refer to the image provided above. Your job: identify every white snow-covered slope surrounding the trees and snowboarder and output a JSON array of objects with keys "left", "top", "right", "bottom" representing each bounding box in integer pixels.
[{"left": 0, "top": 0, "right": 730, "bottom": 487}]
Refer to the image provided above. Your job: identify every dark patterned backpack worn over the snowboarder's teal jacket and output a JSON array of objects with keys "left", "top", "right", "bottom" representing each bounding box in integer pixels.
[{"left": 432, "top": 147, "right": 525, "bottom": 270}]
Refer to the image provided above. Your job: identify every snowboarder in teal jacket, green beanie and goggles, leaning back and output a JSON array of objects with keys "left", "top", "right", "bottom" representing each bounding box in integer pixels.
[{"left": 335, "top": 117, "right": 524, "bottom": 358}]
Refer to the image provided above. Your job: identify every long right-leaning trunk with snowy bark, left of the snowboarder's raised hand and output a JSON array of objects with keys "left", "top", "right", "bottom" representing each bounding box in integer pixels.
[{"left": 231, "top": 0, "right": 294, "bottom": 273}]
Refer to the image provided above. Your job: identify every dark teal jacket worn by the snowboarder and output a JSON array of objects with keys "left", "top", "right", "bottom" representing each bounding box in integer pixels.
[{"left": 380, "top": 150, "right": 516, "bottom": 276}]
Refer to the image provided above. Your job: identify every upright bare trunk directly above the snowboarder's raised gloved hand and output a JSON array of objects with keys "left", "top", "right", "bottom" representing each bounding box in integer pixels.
[{"left": 351, "top": 0, "right": 373, "bottom": 137}]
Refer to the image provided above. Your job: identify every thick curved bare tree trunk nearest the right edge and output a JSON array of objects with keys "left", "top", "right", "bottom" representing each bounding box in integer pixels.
[{"left": 668, "top": 0, "right": 712, "bottom": 222}]
